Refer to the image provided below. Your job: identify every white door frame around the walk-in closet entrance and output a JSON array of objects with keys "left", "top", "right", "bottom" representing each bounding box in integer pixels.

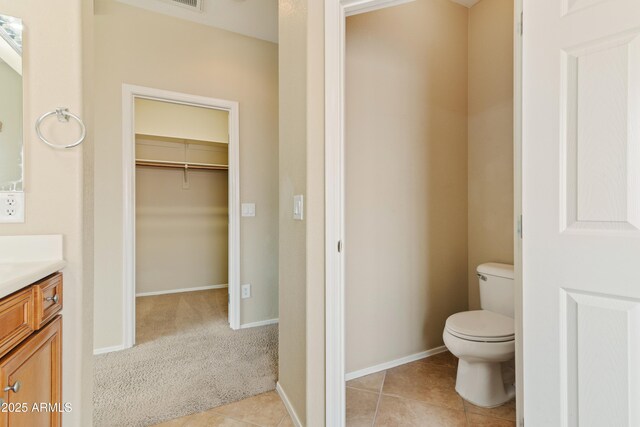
[{"left": 122, "top": 84, "right": 240, "bottom": 348}]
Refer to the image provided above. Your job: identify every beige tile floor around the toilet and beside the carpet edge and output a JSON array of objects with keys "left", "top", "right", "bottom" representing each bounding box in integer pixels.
[{"left": 156, "top": 352, "right": 516, "bottom": 427}]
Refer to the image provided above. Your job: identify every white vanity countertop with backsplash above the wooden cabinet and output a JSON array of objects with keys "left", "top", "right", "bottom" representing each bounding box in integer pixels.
[{"left": 0, "top": 235, "right": 67, "bottom": 298}]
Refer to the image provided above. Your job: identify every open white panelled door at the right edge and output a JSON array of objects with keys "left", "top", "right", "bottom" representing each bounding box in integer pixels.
[{"left": 522, "top": 0, "right": 640, "bottom": 427}]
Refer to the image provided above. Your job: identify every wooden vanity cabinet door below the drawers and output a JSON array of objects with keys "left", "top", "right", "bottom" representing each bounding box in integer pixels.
[{"left": 0, "top": 316, "right": 62, "bottom": 427}]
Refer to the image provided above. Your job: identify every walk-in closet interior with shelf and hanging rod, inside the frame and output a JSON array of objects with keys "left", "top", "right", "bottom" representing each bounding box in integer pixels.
[{"left": 135, "top": 98, "right": 229, "bottom": 344}]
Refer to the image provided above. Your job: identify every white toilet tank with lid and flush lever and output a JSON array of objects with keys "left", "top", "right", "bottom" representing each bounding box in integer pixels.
[{"left": 476, "top": 262, "right": 515, "bottom": 317}]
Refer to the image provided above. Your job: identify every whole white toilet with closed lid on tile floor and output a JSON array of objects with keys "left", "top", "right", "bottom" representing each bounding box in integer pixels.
[{"left": 442, "top": 263, "right": 515, "bottom": 408}]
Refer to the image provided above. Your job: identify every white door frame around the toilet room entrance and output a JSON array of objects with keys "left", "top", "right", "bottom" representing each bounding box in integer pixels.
[{"left": 324, "top": 0, "right": 524, "bottom": 427}]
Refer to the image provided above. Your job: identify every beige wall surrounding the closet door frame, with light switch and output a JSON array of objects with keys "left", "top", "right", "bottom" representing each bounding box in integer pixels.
[{"left": 94, "top": 0, "right": 278, "bottom": 348}]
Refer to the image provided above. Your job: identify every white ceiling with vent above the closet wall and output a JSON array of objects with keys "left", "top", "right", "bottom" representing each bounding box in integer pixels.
[{"left": 118, "top": 0, "right": 278, "bottom": 43}]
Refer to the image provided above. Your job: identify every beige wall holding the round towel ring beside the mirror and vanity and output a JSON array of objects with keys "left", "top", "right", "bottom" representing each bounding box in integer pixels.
[{"left": 0, "top": 0, "right": 93, "bottom": 427}]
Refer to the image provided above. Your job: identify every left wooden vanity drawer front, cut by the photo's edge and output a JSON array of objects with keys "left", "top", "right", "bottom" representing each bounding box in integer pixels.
[{"left": 0, "top": 288, "right": 35, "bottom": 357}]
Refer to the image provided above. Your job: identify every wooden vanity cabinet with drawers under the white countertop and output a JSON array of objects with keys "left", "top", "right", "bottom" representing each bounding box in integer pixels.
[{"left": 0, "top": 273, "right": 64, "bottom": 427}]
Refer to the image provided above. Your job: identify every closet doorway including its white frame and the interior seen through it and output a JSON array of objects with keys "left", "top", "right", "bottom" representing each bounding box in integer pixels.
[{"left": 123, "top": 85, "right": 240, "bottom": 348}]
